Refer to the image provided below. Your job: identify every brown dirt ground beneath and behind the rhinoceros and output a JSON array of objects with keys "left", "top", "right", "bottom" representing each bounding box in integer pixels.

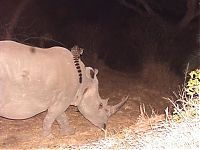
[{"left": 0, "top": 64, "right": 180, "bottom": 149}]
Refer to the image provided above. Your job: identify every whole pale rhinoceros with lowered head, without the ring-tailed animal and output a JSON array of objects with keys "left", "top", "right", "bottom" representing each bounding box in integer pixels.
[{"left": 0, "top": 40, "right": 128, "bottom": 136}]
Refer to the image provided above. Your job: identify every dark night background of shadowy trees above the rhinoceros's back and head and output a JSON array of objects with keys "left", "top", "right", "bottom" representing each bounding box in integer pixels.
[{"left": 0, "top": 0, "right": 199, "bottom": 74}]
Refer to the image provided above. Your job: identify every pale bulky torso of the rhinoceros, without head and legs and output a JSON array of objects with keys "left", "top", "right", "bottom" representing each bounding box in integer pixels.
[{"left": 0, "top": 41, "right": 81, "bottom": 119}]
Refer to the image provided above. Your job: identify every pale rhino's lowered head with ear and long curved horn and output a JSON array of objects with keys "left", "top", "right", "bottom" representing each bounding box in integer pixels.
[{"left": 77, "top": 68, "right": 128, "bottom": 129}]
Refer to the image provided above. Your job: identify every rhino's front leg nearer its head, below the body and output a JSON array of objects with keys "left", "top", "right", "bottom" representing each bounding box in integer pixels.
[{"left": 56, "top": 112, "right": 75, "bottom": 135}]
